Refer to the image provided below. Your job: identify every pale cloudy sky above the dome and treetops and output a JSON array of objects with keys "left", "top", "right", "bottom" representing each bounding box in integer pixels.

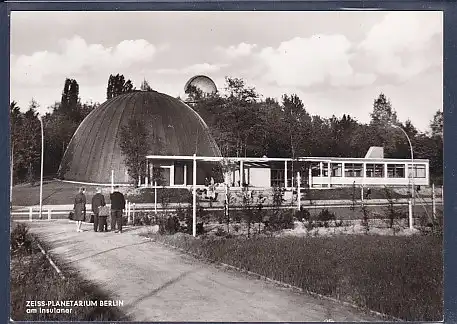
[{"left": 10, "top": 11, "right": 443, "bottom": 131}]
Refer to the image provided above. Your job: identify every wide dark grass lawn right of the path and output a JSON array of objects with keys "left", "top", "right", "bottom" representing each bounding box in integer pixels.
[{"left": 151, "top": 235, "right": 443, "bottom": 321}]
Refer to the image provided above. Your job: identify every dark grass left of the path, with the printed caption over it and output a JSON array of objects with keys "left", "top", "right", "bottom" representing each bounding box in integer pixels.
[{"left": 10, "top": 224, "right": 129, "bottom": 321}]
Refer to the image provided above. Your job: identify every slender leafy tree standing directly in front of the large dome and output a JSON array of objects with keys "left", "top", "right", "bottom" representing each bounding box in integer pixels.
[{"left": 120, "top": 117, "right": 149, "bottom": 185}]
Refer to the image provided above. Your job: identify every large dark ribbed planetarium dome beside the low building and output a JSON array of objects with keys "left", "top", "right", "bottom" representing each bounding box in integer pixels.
[{"left": 59, "top": 91, "right": 221, "bottom": 183}]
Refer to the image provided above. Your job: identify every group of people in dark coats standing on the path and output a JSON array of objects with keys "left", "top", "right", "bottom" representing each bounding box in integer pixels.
[{"left": 73, "top": 186, "right": 125, "bottom": 233}]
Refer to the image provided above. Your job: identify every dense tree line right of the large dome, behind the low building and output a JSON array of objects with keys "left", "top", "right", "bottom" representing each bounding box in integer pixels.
[{"left": 188, "top": 77, "right": 443, "bottom": 183}]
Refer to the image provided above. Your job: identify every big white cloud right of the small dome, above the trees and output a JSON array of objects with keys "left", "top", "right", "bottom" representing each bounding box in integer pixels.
[{"left": 258, "top": 34, "right": 376, "bottom": 88}]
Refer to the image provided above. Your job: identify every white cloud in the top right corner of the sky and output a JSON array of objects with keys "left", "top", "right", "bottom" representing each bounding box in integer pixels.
[{"left": 357, "top": 11, "right": 443, "bottom": 80}]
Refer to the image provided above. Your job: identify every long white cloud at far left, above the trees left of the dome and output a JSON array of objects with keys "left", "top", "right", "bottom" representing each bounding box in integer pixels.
[{"left": 11, "top": 36, "right": 164, "bottom": 85}]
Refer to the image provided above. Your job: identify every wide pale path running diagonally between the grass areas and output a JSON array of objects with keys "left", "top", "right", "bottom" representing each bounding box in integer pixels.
[{"left": 28, "top": 220, "right": 380, "bottom": 322}]
